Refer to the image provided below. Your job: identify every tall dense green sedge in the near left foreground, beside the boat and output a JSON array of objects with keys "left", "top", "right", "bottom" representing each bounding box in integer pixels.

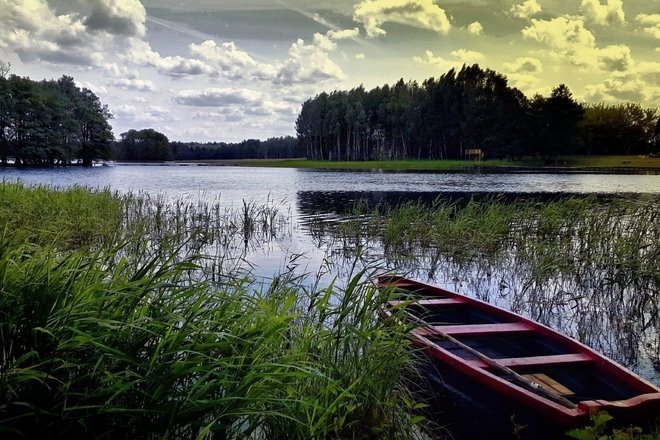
[{"left": 0, "top": 237, "right": 418, "bottom": 439}]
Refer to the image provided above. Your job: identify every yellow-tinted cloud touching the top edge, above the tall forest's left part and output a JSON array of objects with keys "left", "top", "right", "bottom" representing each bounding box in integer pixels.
[{"left": 353, "top": 0, "right": 451, "bottom": 38}]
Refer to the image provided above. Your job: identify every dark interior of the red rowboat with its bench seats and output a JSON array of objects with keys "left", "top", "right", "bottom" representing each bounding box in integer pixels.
[{"left": 390, "top": 284, "right": 640, "bottom": 402}]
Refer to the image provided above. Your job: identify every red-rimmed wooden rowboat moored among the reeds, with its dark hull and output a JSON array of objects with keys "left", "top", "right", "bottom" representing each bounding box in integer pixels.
[{"left": 378, "top": 275, "right": 660, "bottom": 439}]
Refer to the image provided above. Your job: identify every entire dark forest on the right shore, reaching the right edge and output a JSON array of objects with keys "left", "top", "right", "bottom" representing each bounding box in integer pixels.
[{"left": 296, "top": 64, "right": 660, "bottom": 161}]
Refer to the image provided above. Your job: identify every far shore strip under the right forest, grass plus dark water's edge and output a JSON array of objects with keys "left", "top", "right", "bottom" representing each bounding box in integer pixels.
[{"left": 166, "top": 156, "right": 660, "bottom": 174}]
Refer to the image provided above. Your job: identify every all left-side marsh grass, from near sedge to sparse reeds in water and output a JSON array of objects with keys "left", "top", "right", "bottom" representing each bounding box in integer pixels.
[{"left": 0, "top": 184, "right": 421, "bottom": 439}]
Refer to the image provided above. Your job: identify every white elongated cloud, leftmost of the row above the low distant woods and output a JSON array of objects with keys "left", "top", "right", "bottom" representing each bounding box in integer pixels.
[{"left": 126, "top": 39, "right": 213, "bottom": 76}]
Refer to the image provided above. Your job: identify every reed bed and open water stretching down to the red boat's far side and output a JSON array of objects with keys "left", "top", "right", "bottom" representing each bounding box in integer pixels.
[{"left": 310, "top": 196, "right": 660, "bottom": 372}]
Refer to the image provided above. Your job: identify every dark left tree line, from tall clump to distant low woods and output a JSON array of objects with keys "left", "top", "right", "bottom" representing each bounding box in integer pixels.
[{"left": 0, "top": 61, "right": 298, "bottom": 167}]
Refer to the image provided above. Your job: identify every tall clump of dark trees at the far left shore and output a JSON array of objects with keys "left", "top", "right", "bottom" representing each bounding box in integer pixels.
[{"left": 0, "top": 61, "right": 114, "bottom": 166}]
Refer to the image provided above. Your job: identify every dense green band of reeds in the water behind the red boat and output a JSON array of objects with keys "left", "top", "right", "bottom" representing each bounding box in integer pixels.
[{"left": 328, "top": 196, "right": 660, "bottom": 285}]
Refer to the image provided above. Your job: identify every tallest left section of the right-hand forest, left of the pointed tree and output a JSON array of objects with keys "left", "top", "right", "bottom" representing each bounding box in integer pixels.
[{"left": 296, "top": 64, "right": 528, "bottom": 161}]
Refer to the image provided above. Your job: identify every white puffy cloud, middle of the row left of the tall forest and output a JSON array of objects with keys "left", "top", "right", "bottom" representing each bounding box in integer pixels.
[{"left": 190, "top": 40, "right": 277, "bottom": 80}]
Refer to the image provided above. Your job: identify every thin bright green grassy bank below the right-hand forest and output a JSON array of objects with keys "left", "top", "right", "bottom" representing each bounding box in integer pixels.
[{"left": 179, "top": 156, "right": 660, "bottom": 171}]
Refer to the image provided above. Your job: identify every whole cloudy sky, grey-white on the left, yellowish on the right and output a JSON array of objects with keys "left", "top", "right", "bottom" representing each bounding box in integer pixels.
[{"left": 0, "top": 0, "right": 660, "bottom": 141}]
